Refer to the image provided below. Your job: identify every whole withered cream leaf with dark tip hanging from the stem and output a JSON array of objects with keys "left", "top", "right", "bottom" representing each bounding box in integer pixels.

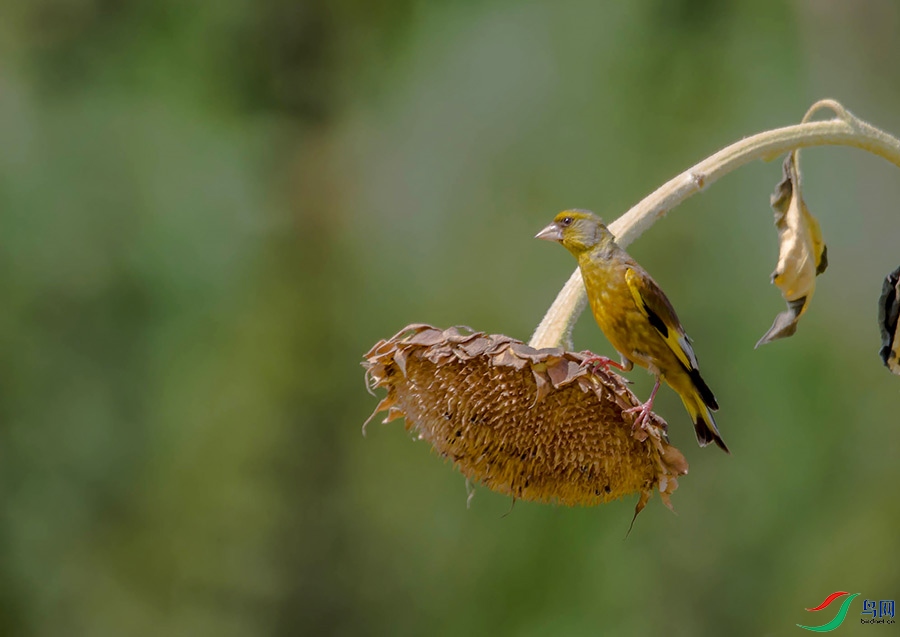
[{"left": 756, "top": 151, "right": 828, "bottom": 347}]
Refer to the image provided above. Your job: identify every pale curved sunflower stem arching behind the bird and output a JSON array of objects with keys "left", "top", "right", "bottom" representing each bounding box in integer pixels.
[{"left": 529, "top": 100, "right": 900, "bottom": 349}]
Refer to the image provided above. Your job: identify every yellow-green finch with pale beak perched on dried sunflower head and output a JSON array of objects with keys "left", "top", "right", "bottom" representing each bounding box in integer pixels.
[{"left": 536, "top": 210, "right": 728, "bottom": 452}]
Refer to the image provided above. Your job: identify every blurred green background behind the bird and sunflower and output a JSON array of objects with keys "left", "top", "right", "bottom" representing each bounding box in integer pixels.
[{"left": 0, "top": 0, "right": 900, "bottom": 637}]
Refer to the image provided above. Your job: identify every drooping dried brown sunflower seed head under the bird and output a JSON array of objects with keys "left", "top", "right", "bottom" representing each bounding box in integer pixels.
[{"left": 363, "top": 324, "right": 688, "bottom": 515}]
